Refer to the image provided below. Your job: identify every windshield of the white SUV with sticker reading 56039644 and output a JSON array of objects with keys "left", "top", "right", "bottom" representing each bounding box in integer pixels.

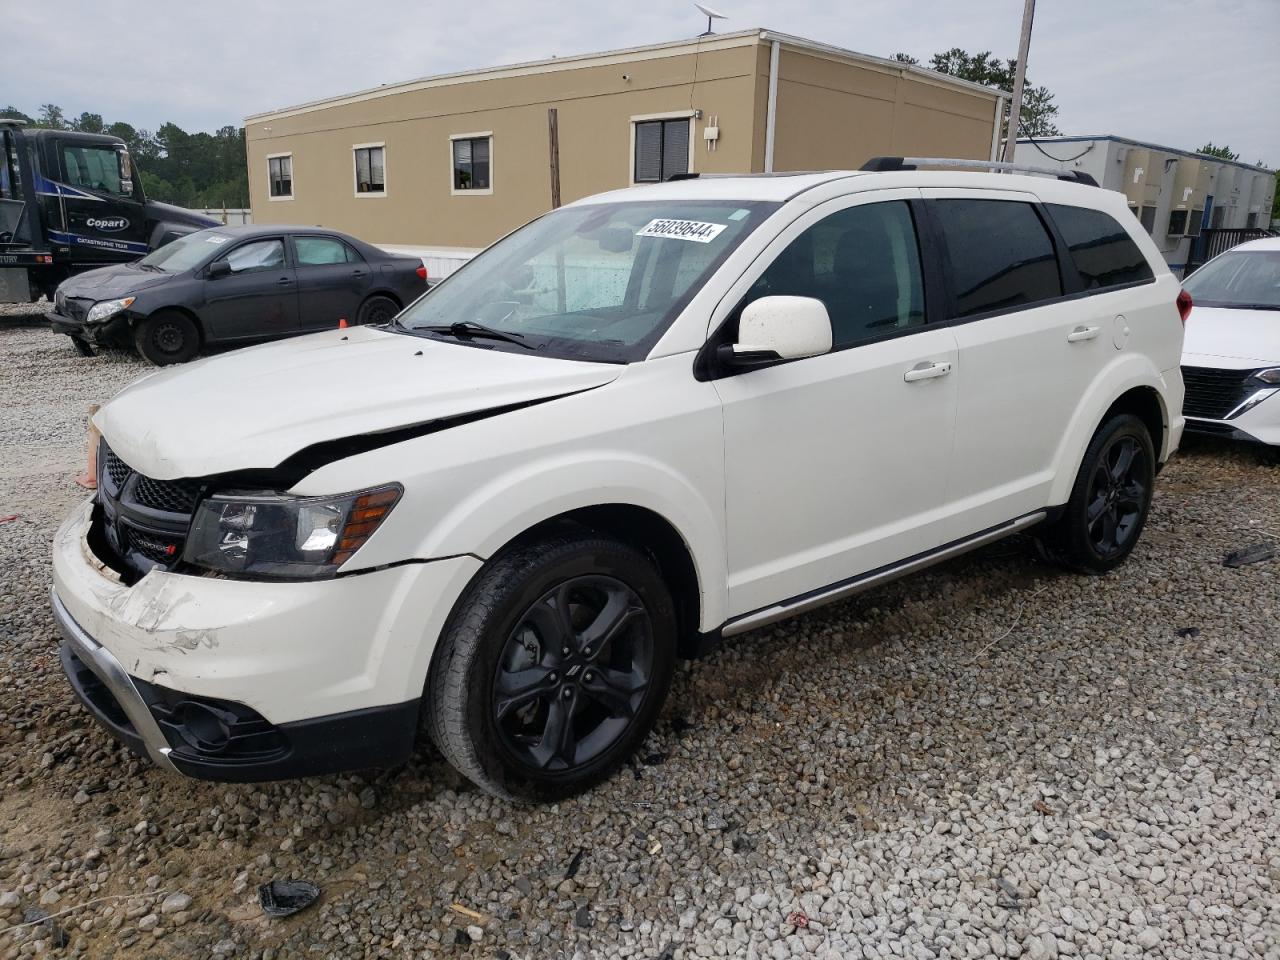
[{"left": 398, "top": 201, "right": 777, "bottom": 364}]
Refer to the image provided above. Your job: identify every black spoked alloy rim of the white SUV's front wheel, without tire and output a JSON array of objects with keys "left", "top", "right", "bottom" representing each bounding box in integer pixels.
[{"left": 490, "top": 576, "right": 654, "bottom": 772}]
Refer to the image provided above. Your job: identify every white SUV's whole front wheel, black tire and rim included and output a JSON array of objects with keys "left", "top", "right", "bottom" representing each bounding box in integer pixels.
[{"left": 425, "top": 530, "right": 676, "bottom": 800}]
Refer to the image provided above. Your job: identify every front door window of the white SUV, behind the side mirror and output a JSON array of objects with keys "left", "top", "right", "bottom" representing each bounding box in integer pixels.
[{"left": 746, "top": 200, "right": 925, "bottom": 349}]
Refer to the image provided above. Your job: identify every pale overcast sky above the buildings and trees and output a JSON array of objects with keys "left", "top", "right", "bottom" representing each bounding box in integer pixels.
[{"left": 0, "top": 0, "right": 1280, "bottom": 168}]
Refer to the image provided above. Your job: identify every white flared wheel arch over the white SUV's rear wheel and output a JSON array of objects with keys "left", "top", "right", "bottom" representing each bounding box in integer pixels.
[{"left": 1048, "top": 353, "right": 1183, "bottom": 507}]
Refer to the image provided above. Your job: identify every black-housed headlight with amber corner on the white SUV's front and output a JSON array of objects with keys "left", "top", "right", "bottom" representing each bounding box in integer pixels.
[{"left": 183, "top": 484, "right": 403, "bottom": 580}]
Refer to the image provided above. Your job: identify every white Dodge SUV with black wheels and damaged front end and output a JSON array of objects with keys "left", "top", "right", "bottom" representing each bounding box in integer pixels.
[{"left": 52, "top": 161, "right": 1187, "bottom": 797}]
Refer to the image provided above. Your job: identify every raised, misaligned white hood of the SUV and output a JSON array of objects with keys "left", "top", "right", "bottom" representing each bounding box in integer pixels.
[{"left": 93, "top": 326, "right": 622, "bottom": 480}]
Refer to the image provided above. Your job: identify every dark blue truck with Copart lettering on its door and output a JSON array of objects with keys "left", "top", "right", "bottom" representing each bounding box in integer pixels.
[{"left": 0, "top": 118, "right": 218, "bottom": 303}]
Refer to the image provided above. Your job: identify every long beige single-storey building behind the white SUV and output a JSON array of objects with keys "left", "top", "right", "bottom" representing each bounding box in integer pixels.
[{"left": 244, "top": 29, "right": 1005, "bottom": 247}]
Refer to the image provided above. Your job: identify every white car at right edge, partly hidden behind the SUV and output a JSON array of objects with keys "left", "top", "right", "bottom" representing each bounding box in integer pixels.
[{"left": 1183, "top": 238, "right": 1280, "bottom": 445}]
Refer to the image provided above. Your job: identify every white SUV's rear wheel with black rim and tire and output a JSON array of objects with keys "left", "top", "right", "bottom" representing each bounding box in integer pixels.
[{"left": 1039, "top": 413, "right": 1156, "bottom": 573}]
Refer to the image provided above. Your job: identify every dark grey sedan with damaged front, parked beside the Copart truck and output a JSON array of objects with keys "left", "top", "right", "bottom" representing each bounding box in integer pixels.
[{"left": 52, "top": 225, "right": 426, "bottom": 365}]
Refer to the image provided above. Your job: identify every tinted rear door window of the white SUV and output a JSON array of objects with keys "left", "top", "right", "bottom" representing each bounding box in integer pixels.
[{"left": 933, "top": 200, "right": 1062, "bottom": 316}]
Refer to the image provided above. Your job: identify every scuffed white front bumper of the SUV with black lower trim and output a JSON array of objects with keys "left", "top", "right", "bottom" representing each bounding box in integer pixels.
[{"left": 52, "top": 500, "right": 479, "bottom": 781}]
